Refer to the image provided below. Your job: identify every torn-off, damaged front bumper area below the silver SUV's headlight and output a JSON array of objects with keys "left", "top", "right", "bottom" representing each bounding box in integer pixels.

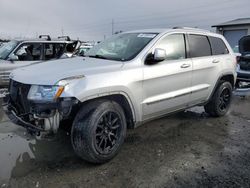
[{"left": 3, "top": 95, "right": 78, "bottom": 135}]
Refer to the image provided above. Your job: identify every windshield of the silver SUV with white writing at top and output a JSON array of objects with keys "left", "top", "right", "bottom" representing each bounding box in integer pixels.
[{"left": 85, "top": 33, "right": 157, "bottom": 61}]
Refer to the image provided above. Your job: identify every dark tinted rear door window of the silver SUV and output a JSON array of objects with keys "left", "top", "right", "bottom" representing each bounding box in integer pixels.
[{"left": 189, "top": 35, "right": 212, "bottom": 57}]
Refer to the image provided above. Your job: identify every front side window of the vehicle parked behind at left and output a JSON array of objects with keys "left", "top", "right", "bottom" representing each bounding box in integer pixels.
[{"left": 14, "top": 43, "right": 42, "bottom": 61}]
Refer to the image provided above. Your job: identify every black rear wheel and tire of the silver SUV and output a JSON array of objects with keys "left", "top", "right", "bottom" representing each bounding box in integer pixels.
[{"left": 204, "top": 81, "right": 233, "bottom": 117}]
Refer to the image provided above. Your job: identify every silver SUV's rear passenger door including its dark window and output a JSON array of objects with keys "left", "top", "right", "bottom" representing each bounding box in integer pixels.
[{"left": 188, "top": 34, "right": 222, "bottom": 105}]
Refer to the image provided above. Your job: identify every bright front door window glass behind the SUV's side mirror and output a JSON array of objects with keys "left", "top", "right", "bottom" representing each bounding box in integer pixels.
[{"left": 156, "top": 34, "right": 186, "bottom": 60}]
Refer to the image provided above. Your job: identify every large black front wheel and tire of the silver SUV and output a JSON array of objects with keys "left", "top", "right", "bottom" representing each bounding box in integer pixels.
[{"left": 71, "top": 100, "right": 127, "bottom": 163}]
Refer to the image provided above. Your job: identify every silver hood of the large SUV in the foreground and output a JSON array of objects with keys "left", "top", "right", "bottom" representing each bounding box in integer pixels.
[{"left": 10, "top": 57, "right": 123, "bottom": 85}]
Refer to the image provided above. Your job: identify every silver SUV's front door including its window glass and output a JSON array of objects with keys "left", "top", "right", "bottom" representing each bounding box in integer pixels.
[{"left": 142, "top": 34, "right": 192, "bottom": 120}]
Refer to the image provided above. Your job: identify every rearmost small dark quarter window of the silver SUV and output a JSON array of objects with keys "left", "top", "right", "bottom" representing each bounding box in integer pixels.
[{"left": 209, "top": 37, "right": 229, "bottom": 55}]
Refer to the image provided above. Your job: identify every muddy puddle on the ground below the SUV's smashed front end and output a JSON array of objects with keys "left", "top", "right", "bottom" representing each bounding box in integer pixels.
[{"left": 0, "top": 111, "right": 75, "bottom": 185}]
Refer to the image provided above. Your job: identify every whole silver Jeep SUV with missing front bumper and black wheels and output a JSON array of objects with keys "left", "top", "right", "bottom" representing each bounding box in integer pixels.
[{"left": 5, "top": 28, "right": 236, "bottom": 163}]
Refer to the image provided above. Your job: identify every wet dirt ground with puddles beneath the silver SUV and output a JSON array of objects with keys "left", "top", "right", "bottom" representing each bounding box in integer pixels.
[{"left": 0, "top": 97, "right": 250, "bottom": 188}]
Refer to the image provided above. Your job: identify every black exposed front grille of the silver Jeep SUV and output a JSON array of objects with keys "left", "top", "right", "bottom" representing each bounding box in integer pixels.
[{"left": 9, "top": 80, "right": 30, "bottom": 115}]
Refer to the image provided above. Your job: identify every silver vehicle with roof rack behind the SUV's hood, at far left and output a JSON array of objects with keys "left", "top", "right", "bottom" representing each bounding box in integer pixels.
[{"left": 0, "top": 35, "right": 79, "bottom": 87}]
